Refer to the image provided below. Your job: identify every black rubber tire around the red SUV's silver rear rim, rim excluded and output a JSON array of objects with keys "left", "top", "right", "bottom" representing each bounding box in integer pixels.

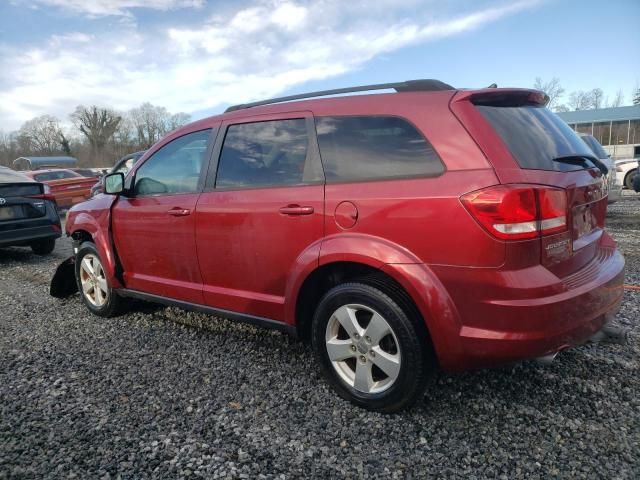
[{"left": 312, "top": 279, "right": 436, "bottom": 413}]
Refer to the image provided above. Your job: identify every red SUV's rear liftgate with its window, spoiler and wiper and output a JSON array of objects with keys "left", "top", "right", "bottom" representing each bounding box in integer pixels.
[{"left": 452, "top": 90, "right": 607, "bottom": 277}]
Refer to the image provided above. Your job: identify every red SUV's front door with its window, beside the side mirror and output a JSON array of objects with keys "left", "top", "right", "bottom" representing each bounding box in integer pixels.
[{"left": 112, "top": 129, "right": 212, "bottom": 304}]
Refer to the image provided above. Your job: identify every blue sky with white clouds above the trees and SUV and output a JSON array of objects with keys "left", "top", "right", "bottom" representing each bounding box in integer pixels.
[{"left": 0, "top": 0, "right": 640, "bottom": 131}]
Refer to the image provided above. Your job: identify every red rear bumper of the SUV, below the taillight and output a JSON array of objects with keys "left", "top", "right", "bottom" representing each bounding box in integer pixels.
[{"left": 432, "top": 244, "right": 624, "bottom": 371}]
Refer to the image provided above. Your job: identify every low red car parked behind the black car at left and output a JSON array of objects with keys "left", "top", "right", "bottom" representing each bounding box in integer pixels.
[{"left": 24, "top": 168, "right": 96, "bottom": 208}]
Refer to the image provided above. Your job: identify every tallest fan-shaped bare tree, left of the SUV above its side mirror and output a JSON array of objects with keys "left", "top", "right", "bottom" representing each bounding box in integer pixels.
[{"left": 71, "top": 105, "right": 122, "bottom": 163}]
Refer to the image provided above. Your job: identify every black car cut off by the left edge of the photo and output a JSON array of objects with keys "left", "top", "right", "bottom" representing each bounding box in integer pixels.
[{"left": 0, "top": 167, "right": 62, "bottom": 255}]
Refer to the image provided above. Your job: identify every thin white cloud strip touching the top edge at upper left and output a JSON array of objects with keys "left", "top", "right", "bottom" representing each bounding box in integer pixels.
[{"left": 20, "top": 0, "right": 204, "bottom": 17}]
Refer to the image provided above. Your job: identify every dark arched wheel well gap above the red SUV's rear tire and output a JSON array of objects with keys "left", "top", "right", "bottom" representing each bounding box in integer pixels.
[{"left": 296, "top": 262, "right": 431, "bottom": 344}]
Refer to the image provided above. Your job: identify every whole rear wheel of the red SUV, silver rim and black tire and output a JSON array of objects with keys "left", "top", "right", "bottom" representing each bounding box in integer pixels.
[{"left": 312, "top": 283, "right": 434, "bottom": 412}]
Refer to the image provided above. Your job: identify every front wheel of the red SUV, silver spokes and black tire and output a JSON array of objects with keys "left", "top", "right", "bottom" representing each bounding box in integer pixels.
[{"left": 76, "top": 242, "right": 126, "bottom": 317}]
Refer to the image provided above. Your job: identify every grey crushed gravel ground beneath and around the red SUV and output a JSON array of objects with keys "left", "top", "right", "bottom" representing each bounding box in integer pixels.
[{"left": 0, "top": 196, "right": 640, "bottom": 479}]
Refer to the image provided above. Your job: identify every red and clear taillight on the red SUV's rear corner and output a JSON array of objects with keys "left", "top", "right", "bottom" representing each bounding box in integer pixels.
[{"left": 460, "top": 185, "right": 567, "bottom": 240}]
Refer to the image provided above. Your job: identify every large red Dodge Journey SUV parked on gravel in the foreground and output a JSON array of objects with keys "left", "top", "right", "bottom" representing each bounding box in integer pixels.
[{"left": 61, "top": 80, "right": 624, "bottom": 412}]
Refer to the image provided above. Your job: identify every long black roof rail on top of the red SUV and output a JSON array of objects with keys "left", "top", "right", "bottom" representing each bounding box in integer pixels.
[{"left": 225, "top": 79, "right": 455, "bottom": 113}]
